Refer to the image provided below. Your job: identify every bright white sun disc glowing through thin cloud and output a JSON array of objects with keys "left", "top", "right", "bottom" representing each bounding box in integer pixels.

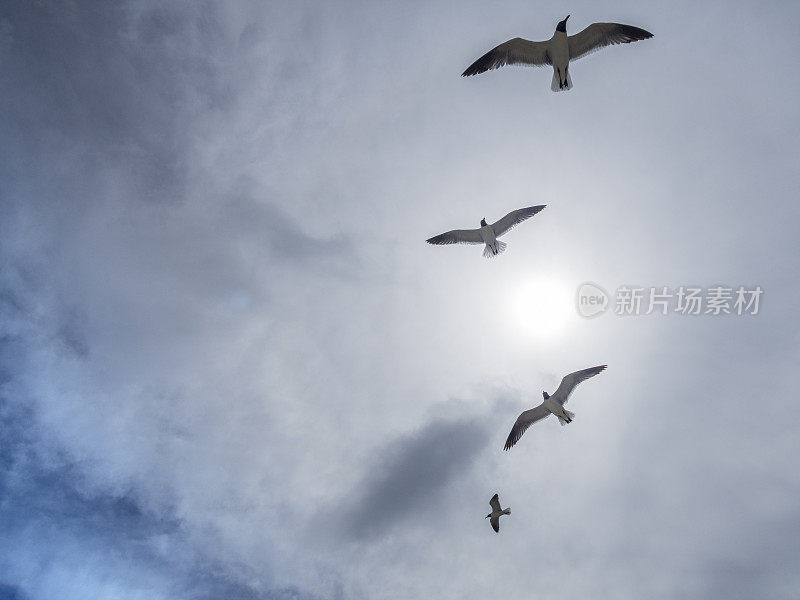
[{"left": 509, "top": 278, "right": 576, "bottom": 338}]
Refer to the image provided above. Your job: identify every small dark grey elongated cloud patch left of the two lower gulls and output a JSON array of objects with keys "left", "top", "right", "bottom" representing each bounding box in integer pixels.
[{"left": 346, "top": 419, "right": 490, "bottom": 539}]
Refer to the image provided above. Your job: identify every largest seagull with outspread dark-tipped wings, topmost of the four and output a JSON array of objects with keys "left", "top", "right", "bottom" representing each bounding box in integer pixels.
[{"left": 461, "top": 15, "right": 653, "bottom": 92}]
